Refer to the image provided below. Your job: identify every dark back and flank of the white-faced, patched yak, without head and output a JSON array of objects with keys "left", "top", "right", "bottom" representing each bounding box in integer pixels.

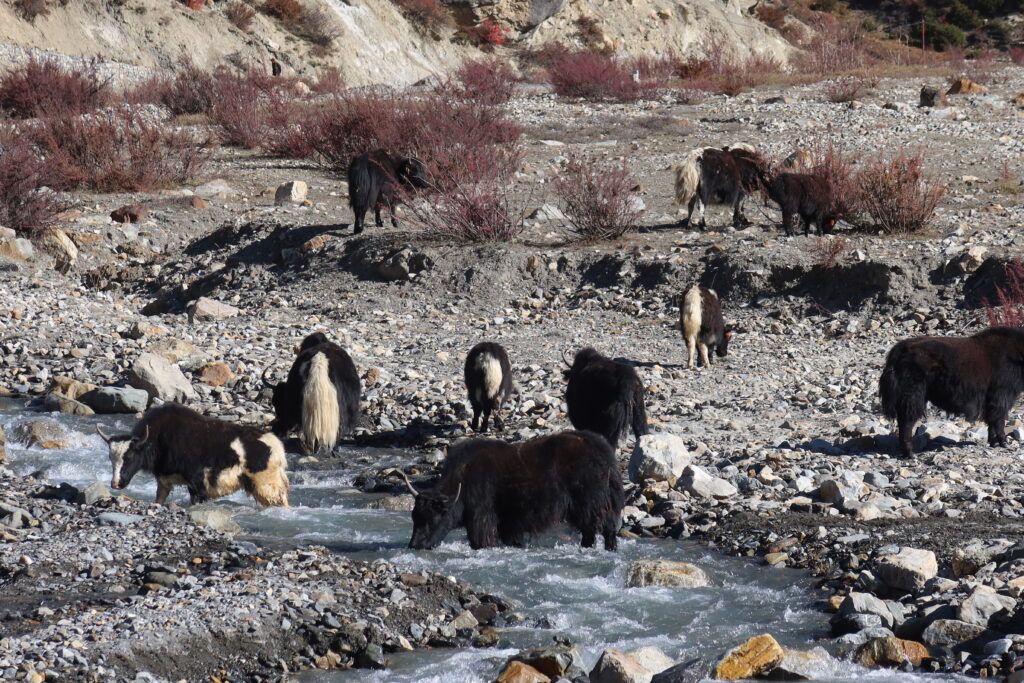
[{"left": 132, "top": 403, "right": 270, "bottom": 478}]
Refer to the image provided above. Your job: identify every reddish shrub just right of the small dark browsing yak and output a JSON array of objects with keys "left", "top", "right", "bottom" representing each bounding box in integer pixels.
[{"left": 857, "top": 150, "right": 945, "bottom": 233}]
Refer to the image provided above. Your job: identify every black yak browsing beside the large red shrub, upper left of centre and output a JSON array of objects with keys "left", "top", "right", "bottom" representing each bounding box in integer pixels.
[{"left": 348, "top": 150, "right": 428, "bottom": 233}]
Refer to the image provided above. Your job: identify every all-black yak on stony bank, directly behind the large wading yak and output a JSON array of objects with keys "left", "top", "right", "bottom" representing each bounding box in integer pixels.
[{"left": 563, "top": 347, "right": 647, "bottom": 449}]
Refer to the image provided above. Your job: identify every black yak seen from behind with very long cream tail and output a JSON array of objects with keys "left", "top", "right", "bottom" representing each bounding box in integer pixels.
[{"left": 263, "top": 332, "right": 362, "bottom": 453}]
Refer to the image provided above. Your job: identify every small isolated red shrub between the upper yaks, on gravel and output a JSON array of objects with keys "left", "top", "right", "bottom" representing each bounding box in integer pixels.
[{"left": 554, "top": 157, "right": 640, "bottom": 242}]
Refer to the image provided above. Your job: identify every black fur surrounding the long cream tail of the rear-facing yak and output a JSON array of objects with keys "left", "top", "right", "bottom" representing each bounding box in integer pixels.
[{"left": 270, "top": 332, "right": 362, "bottom": 436}]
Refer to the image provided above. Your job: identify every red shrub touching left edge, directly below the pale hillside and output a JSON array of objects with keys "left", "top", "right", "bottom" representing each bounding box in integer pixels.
[{"left": 0, "top": 57, "right": 110, "bottom": 119}]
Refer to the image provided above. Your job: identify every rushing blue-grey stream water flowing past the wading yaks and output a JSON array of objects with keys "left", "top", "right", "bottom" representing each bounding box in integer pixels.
[{"left": 0, "top": 401, "right": 966, "bottom": 683}]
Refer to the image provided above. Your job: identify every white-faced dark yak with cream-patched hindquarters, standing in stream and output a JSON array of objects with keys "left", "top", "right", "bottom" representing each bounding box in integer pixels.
[{"left": 96, "top": 403, "right": 288, "bottom": 507}]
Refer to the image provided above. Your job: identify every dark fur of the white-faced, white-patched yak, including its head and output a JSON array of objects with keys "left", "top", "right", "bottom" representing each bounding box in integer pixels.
[{"left": 115, "top": 403, "right": 270, "bottom": 503}]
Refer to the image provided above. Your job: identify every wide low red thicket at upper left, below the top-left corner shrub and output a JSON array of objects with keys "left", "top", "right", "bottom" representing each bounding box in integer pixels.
[{"left": 31, "top": 108, "right": 209, "bottom": 191}]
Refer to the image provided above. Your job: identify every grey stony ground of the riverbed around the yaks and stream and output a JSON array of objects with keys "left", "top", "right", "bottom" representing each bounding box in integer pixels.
[{"left": 6, "top": 49, "right": 1024, "bottom": 680}]
